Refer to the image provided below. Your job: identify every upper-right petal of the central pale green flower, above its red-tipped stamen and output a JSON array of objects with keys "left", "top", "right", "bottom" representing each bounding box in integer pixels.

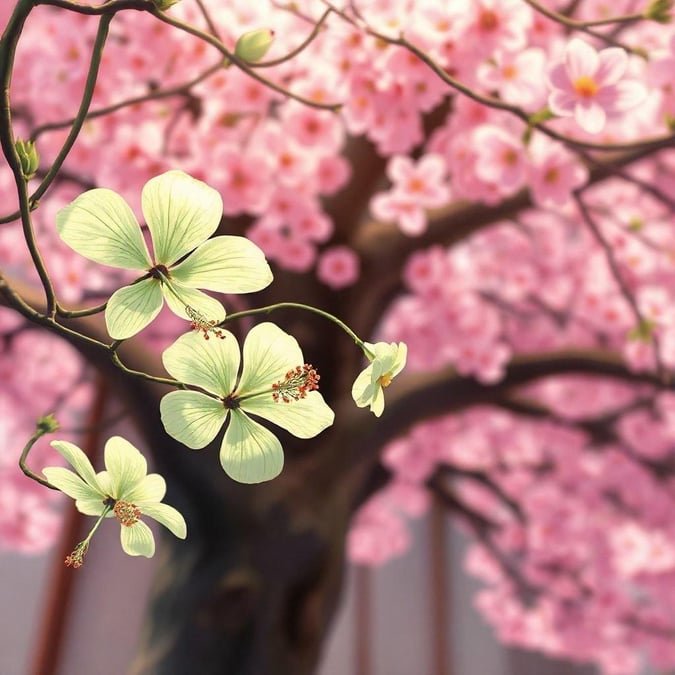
[{"left": 238, "top": 322, "right": 304, "bottom": 396}]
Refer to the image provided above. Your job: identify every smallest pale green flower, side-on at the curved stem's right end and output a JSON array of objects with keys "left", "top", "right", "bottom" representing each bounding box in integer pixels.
[{"left": 352, "top": 342, "right": 408, "bottom": 417}]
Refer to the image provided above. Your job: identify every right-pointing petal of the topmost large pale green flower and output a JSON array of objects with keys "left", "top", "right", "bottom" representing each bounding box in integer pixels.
[{"left": 171, "top": 236, "right": 272, "bottom": 293}]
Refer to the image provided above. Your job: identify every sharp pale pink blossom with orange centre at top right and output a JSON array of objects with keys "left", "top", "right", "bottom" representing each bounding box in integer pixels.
[{"left": 548, "top": 38, "right": 647, "bottom": 134}]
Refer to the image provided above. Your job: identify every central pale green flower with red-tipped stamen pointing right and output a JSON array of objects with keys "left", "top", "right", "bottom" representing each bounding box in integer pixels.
[{"left": 160, "top": 323, "right": 335, "bottom": 483}]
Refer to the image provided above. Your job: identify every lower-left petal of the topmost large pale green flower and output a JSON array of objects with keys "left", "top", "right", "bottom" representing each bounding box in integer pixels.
[{"left": 105, "top": 279, "right": 163, "bottom": 340}]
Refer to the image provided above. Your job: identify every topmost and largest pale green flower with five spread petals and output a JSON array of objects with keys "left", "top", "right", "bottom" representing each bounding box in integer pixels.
[{"left": 56, "top": 171, "right": 272, "bottom": 340}]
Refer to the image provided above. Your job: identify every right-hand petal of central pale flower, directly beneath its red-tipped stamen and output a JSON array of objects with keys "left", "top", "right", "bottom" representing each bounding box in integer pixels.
[{"left": 241, "top": 391, "right": 335, "bottom": 438}]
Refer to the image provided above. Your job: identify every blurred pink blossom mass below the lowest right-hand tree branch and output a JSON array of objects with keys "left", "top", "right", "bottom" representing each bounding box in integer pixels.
[{"left": 349, "top": 394, "right": 675, "bottom": 675}]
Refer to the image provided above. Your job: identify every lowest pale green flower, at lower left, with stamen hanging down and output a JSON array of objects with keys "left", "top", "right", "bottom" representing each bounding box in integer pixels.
[{"left": 43, "top": 436, "right": 187, "bottom": 567}]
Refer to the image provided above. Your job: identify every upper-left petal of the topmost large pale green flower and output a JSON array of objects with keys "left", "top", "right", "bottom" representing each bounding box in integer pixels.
[{"left": 56, "top": 188, "right": 152, "bottom": 270}]
